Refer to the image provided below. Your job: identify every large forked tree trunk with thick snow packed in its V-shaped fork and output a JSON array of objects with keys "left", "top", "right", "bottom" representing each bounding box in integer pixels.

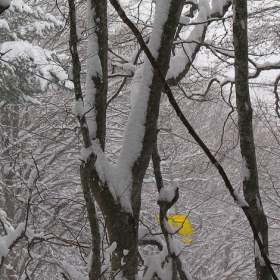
[{"left": 69, "top": 0, "right": 184, "bottom": 280}]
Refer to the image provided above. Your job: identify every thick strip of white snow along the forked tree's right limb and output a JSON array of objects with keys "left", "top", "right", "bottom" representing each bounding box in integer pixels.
[{"left": 105, "top": 0, "right": 182, "bottom": 212}]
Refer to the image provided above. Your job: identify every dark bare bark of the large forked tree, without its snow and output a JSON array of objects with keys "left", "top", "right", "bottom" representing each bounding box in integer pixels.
[{"left": 69, "top": 0, "right": 184, "bottom": 280}]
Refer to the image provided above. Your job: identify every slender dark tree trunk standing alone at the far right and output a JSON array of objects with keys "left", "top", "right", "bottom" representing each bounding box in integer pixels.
[{"left": 233, "top": 0, "right": 271, "bottom": 280}]
